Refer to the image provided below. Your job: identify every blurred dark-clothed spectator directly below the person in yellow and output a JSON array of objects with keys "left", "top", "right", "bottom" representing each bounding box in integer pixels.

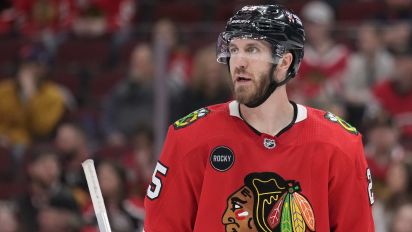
[{"left": 18, "top": 147, "right": 80, "bottom": 231}]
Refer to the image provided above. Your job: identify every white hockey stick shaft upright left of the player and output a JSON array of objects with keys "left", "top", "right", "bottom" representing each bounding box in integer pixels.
[{"left": 82, "top": 159, "right": 112, "bottom": 232}]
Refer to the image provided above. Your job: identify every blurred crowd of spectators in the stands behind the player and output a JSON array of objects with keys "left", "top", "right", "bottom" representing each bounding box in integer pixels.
[{"left": 0, "top": 0, "right": 412, "bottom": 232}]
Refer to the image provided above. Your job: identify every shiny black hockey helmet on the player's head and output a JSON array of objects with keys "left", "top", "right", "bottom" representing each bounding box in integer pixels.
[{"left": 217, "top": 5, "right": 305, "bottom": 79}]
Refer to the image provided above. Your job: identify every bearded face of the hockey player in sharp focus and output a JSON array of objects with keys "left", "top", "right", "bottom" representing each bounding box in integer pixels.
[{"left": 229, "top": 39, "right": 273, "bottom": 104}]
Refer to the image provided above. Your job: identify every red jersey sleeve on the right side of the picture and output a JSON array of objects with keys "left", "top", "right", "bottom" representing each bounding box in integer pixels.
[{"left": 328, "top": 135, "right": 374, "bottom": 232}]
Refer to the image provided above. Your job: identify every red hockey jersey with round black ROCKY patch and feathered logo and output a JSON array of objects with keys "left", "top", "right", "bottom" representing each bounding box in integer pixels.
[{"left": 145, "top": 101, "right": 374, "bottom": 232}]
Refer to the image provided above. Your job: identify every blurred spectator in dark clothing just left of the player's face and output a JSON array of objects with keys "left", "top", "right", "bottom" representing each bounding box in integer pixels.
[{"left": 176, "top": 45, "right": 231, "bottom": 119}]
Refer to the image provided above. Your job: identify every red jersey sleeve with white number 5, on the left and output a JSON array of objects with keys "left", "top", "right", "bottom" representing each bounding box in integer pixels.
[{"left": 144, "top": 126, "right": 205, "bottom": 232}]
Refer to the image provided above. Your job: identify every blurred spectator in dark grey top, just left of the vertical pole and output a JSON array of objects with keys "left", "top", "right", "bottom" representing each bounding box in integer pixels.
[{"left": 102, "top": 44, "right": 154, "bottom": 145}]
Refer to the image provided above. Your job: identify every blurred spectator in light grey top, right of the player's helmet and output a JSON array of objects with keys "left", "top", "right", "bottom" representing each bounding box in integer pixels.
[{"left": 344, "top": 23, "right": 394, "bottom": 128}]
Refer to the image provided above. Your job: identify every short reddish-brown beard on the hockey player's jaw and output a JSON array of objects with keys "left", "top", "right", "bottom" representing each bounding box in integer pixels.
[{"left": 233, "top": 71, "right": 269, "bottom": 105}]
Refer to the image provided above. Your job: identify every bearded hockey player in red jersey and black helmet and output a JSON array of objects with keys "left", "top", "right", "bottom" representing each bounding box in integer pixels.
[{"left": 145, "top": 5, "right": 374, "bottom": 232}]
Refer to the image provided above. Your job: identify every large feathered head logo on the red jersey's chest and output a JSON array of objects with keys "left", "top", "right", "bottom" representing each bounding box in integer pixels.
[{"left": 222, "top": 172, "right": 315, "bottom": 232}]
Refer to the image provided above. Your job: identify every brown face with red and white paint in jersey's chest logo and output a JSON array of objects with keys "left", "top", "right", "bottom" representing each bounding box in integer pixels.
[{"left": 222, "top": 186, "right": 256, "bottom": 232}]
